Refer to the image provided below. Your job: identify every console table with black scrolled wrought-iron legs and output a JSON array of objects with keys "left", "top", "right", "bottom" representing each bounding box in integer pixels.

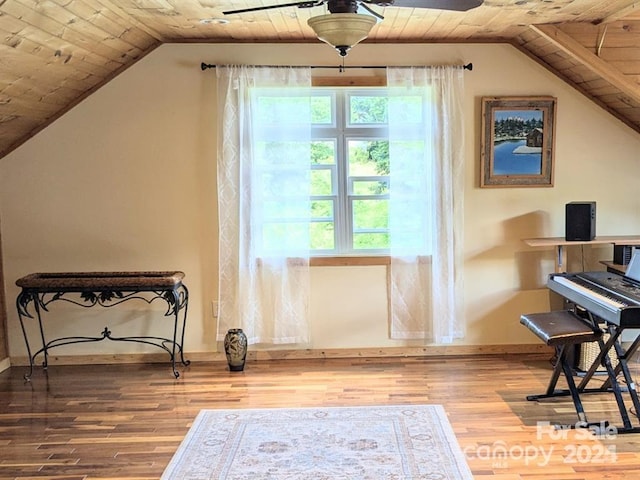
[{"left": 16, "top": 272, "right": 190, "bottom": 380}]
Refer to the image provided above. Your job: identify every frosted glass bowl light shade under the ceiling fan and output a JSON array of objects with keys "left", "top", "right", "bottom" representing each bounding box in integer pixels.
[{"left": 307, "top": 13, "right": 376, "bottom": 57}]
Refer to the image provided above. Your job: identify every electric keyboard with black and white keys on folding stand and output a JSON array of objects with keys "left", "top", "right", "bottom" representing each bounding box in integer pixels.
[{"left": 547, "top": 272, "right": 640, "bottom": 328}]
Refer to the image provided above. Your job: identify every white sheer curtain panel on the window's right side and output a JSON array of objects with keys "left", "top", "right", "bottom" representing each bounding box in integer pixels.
[{"left": 387, "top": 67, "right": 464, "bottom": 343}]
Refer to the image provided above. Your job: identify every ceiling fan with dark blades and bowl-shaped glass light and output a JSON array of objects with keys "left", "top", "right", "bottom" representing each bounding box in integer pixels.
[{"left": 222, "top": 0, "right": 484, "bottom": 57}]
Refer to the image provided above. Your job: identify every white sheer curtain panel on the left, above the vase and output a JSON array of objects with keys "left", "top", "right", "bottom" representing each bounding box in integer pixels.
[{"left": 216, "top": 66, "right": 311, "bottom": 344}]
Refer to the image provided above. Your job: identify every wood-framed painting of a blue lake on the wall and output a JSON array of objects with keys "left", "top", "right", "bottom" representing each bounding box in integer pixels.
[{"left": 480, "top": 97, "right": 556, "bottom": 187}]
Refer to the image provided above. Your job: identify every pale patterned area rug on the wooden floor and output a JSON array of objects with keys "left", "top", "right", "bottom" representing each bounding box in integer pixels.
[{"left": 161, "top": 405, "right": 473, "bottom": 480}]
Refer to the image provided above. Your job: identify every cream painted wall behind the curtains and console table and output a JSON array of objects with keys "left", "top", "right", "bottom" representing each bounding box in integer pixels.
[{"left": 0, "top": 44, "right": 640, "bottom": 357}]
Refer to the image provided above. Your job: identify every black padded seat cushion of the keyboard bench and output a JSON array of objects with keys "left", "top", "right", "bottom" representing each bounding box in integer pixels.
[{"left": 520, "top": 310, "right": 602, "bottom": 347}]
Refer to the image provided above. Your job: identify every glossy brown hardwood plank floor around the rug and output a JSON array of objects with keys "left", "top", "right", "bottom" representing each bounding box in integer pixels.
[{"left": 0, "top": 354, "right": 640, "bottom": 480}]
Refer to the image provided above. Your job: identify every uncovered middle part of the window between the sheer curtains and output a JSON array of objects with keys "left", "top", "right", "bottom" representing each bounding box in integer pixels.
[{"left": 311, "top": 89, "right": 389, "bottom": 255}]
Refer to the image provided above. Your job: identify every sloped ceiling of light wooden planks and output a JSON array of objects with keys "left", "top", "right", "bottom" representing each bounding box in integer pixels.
[{"left": 0, "top": 0, "right": 640, "bottom": 158}]
